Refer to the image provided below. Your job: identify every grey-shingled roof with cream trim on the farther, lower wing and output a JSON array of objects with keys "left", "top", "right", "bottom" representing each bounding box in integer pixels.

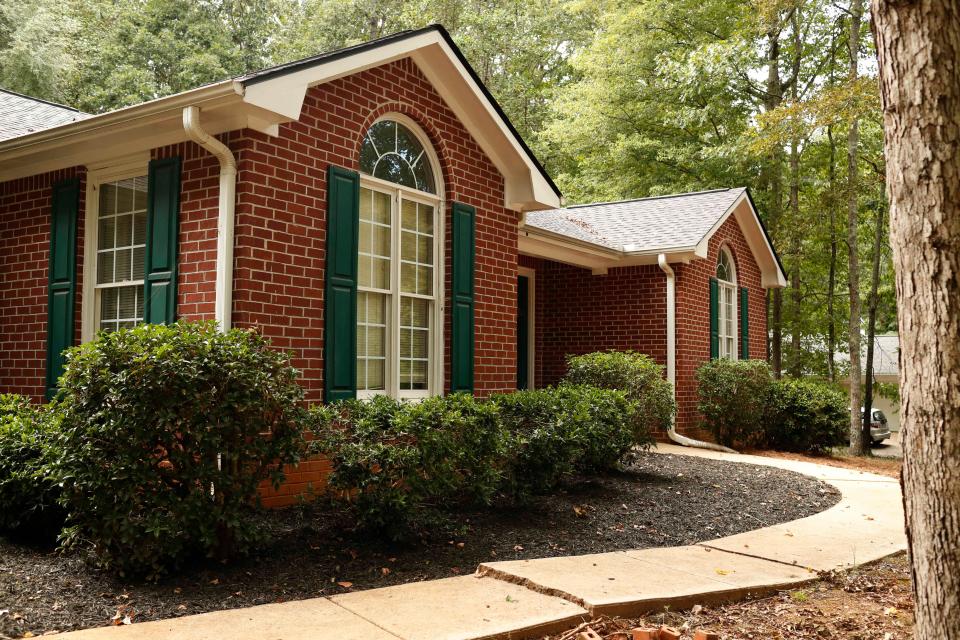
[{"left": 520, "top": 187, "right": 786, "bottom": 288}]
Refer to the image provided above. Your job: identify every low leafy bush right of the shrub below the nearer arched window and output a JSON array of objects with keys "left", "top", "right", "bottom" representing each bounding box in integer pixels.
[{"left": 494, "top": 384, "right": 649, "bottom": 498}]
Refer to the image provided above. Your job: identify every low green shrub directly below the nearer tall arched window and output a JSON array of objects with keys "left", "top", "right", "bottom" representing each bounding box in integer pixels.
[{"left": 311, "top": 394, "right": 506, "bottom": 538}]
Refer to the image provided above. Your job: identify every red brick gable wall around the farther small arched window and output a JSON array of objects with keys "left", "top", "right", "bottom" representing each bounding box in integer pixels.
[{"left": 674, "top": 216, "right": 767, "bottom": 438}]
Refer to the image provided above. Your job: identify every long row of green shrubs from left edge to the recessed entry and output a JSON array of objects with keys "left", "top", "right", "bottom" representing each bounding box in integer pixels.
[{"left": 0, "top": 323, "right": 672, "bottom": 578}]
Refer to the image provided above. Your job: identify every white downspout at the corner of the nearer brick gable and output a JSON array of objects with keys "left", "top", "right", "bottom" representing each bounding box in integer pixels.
[{"left": 183, "top": 105, "right": 237, "bottom": 331}]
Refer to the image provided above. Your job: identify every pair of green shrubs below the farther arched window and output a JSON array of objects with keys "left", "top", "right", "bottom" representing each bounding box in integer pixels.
[{"left": 697, "top": 360, "right": 849, "bottom": 454}]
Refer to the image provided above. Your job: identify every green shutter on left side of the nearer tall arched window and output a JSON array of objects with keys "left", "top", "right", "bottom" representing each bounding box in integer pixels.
[{"left": 323, "top": 165, "right": 360, "bottom": 402}]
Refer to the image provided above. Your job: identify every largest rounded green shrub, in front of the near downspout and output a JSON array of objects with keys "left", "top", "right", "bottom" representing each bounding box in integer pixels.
[{"left": 51, "top": 323, "right": 303, "bottom": 577}]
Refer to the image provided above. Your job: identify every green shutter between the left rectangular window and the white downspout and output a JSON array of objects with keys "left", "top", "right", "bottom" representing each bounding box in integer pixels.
[{"left": 143, "top": 158, "right": 180, "bottom": 324}]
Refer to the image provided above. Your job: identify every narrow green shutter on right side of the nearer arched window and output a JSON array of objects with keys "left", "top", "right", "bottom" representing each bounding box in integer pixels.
[{"left": 450, "top": 202, "right": 477, "bottom": 393}]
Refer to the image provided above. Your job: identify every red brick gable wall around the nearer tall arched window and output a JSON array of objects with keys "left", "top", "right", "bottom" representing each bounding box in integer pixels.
[{"left": 231, "top": 59, "right": 517, "bottom": 408}]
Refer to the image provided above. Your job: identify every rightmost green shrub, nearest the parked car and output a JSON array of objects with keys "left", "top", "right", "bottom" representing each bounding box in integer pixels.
[{"left": 764, "top": 379, "right": 850, "bottom": 454}]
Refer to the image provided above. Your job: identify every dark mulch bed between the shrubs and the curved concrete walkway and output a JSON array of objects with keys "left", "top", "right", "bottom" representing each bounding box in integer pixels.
[{"left": 0, "top": 454, "right": 840, "bottom": 637}]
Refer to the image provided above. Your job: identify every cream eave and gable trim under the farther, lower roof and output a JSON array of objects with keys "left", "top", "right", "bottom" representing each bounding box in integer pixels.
[{"left": 519, "top": 190, "right": 787, "bottom": 289}]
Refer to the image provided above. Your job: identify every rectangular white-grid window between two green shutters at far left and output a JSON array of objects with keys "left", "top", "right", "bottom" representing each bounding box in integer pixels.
[{"left": 95, "top": 176, "right": 147, "bottom": 331}]
